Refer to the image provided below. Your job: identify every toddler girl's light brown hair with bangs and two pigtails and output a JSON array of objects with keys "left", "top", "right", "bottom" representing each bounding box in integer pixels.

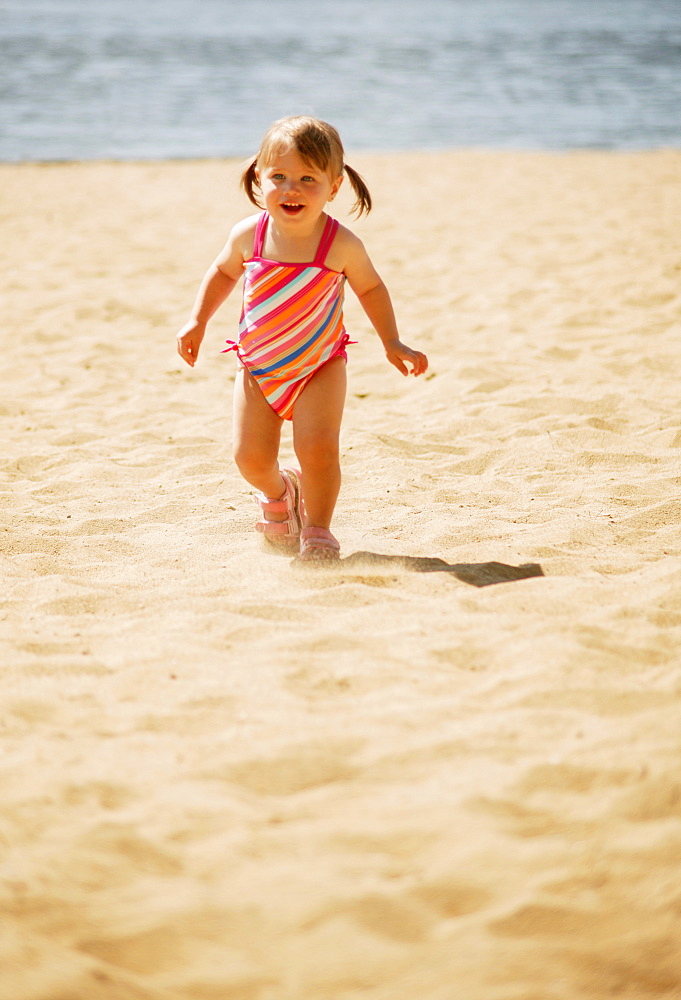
[{"left": 241, "top": 115, "right": 371, "bottom": 215}]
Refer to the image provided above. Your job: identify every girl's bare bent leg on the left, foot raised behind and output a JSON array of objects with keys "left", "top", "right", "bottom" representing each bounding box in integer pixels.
[{"left": 234, "top": 369, "right": 286, "bottom": 500}]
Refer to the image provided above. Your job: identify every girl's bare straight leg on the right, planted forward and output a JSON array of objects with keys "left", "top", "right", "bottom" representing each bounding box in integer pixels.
[{"left": 293, "top": 358, "right": 346, "bottom": 529}]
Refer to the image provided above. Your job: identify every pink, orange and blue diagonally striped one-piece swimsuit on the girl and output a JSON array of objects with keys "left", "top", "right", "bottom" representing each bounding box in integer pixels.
[{"left": 223, "top": 212, "right": 349, "bottom": 420}]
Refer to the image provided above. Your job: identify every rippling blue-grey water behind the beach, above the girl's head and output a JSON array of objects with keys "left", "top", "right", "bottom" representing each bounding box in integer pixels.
[{"left": 0, "top": 0, "right": 681, "bottom": 161}]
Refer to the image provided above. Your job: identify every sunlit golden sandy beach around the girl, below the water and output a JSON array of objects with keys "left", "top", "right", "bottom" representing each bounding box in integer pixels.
[{"left": 0, "top": 150, "right": 681, "bottom": 1000}]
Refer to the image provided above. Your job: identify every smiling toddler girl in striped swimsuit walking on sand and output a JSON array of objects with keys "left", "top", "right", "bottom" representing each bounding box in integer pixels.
[{"left": 177, "top": 117, "right": 428, "bottom": 560}]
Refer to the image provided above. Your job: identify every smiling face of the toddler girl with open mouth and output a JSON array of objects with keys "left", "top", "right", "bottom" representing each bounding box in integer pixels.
[{"left": 256, "top": 147, "right": 343, "bottom": 232}]
